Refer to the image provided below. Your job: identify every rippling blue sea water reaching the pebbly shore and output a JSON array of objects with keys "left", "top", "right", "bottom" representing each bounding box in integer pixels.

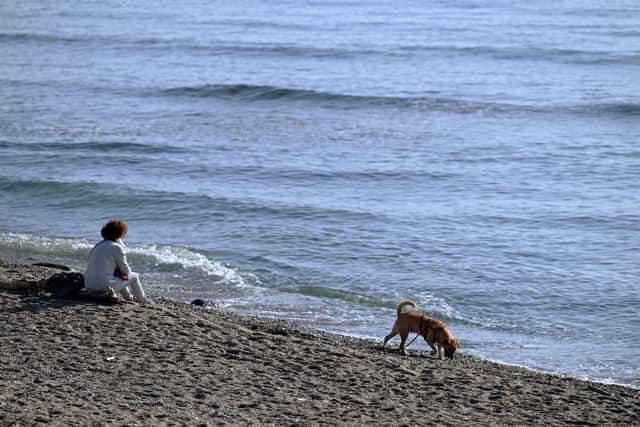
[{"left": 0, "top": 0, "right": 640, "bottom": 386}]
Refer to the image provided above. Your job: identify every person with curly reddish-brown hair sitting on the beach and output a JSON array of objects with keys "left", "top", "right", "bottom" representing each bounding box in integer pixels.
[{"left": 84, "top": 219, "right": 148, "bottom": 304}]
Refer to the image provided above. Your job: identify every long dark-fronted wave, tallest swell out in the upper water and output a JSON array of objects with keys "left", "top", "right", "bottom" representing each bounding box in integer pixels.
[{"left": 158, "top": 84, "right": 640, "bottom": 115}]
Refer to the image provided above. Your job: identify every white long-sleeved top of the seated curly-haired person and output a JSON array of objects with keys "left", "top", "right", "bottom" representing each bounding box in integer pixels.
[{"left": 84, "top": 240, "right": 131, "bottom": 289}]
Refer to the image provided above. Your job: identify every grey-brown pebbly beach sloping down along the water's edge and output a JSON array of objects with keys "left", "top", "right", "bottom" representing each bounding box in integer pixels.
[{"left": 0, "top": 263, "right": 640, "bottom": 426}]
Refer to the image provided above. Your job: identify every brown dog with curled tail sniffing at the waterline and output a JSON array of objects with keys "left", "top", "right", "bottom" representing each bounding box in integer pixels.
[{"left": 382, "top": 300, "right": 458, "bottom": 359}]
